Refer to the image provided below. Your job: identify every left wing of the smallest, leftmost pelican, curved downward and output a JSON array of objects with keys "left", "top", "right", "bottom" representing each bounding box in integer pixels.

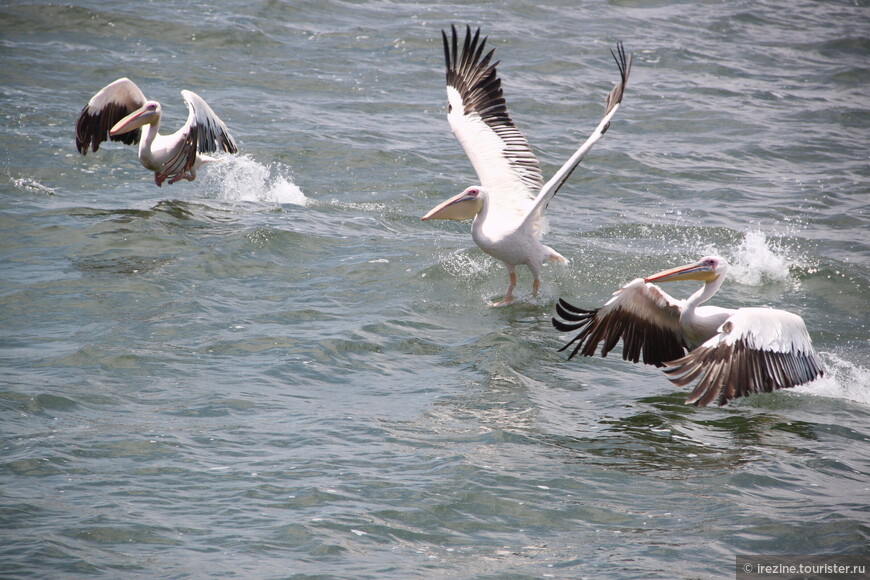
[{"left": 76, "top": 78, "right": 146, "bottom": 155}]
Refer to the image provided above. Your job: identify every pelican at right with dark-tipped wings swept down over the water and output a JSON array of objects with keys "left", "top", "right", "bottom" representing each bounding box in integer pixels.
[{"left": 553, "top": 256, "right": 824, "bottom": 407}]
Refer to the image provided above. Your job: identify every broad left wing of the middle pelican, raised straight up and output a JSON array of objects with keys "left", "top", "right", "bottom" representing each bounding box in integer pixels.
[{"left": 441, "top": 26, "right": 544, "bottom": 214}]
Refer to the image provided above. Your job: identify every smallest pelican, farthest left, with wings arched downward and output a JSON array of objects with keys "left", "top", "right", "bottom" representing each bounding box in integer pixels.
[{"left": 76, "top": 78, "right": 239, "bottom": 187}]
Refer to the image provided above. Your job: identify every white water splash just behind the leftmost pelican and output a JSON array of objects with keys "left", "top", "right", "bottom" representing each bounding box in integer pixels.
[{"left": 201, "top": 155, "right": 308, "bottom": 205}]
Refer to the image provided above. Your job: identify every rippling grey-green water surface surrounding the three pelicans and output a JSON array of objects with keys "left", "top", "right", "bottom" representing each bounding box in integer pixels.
[{"left": 0, "top": 0, "right": 870, "bottom": 579}]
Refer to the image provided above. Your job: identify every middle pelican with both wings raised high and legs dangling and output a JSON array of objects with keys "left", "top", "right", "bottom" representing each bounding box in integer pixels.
[{"left": 422, "top": 26, "right": 631, "bottom": 306}]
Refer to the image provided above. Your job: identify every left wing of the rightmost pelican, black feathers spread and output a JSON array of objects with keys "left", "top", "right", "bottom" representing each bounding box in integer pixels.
[{"left": 553, "top": 278, "right": 686, "bottom": 367}]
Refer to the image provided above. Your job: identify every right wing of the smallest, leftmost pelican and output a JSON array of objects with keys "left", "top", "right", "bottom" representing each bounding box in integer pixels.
[{"left": 154, "top": 91, "right": 239, "bottom": 185}]
